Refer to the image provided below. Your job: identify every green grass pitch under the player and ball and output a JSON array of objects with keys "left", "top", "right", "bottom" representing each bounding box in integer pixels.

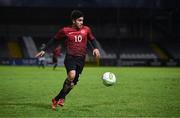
[{"left": 0, "top": 66, "right": 180, "bottom": 118}]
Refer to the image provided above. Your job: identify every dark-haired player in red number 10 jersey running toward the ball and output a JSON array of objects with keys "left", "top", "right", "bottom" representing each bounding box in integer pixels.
[{"left": 36, "top": 10, "right": 100, "bottom": 109}]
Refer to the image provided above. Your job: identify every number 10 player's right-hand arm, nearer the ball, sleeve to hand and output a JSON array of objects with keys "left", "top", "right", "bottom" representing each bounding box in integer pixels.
[{"left": 88, "top": 28, "right": 100, "bottom": 59}]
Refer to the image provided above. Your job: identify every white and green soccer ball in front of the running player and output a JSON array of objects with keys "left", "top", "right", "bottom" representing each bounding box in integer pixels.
[{"left": 102, "top": 72, "right": 116, "bottom": 86}]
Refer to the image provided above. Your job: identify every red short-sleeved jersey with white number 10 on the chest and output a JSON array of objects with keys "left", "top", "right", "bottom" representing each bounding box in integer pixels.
[{"left": 54, "top": 26, "right": 95, "bottom": 56}]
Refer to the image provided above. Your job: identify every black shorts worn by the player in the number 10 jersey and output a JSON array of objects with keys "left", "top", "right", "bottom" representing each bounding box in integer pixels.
[{"left": 64, "top": 55, "right": 85, "bottom": 74}]
